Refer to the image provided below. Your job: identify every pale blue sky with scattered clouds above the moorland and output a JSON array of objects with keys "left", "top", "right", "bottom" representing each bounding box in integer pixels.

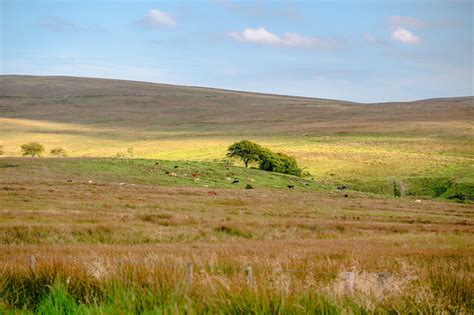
[{"left": 0, "top": 0, "right": 474, "bottom": 102}]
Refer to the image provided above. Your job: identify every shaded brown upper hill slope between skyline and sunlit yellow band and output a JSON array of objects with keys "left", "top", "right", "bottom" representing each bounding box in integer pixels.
[{"left": 0, "top": 76, "right": 474, "bottom": 135}]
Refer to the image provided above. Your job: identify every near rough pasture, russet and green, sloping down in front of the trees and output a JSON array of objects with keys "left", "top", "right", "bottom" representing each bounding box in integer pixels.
[{"left": 0, "top": 158, "right": 474, "bottom": 313}]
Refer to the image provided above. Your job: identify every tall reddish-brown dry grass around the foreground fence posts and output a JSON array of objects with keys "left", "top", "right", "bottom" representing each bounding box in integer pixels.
[{"left": 0, "top": 243, "right": 474, "bottom": 314}]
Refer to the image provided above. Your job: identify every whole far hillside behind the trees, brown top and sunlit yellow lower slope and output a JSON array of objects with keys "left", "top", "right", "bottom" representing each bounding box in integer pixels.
[{"left": 0, "top": 76, "right": 474, "bottom": 196}]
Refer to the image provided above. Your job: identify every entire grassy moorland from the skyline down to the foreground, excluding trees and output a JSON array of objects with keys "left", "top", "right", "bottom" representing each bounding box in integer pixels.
[{"left": 0, "top": 76, "right": 474, "bottom": 314}]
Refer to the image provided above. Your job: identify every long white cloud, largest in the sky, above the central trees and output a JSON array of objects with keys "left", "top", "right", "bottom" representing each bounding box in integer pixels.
[{"left": 228, "top": 27, "right": 339, "bottom": 49}]
